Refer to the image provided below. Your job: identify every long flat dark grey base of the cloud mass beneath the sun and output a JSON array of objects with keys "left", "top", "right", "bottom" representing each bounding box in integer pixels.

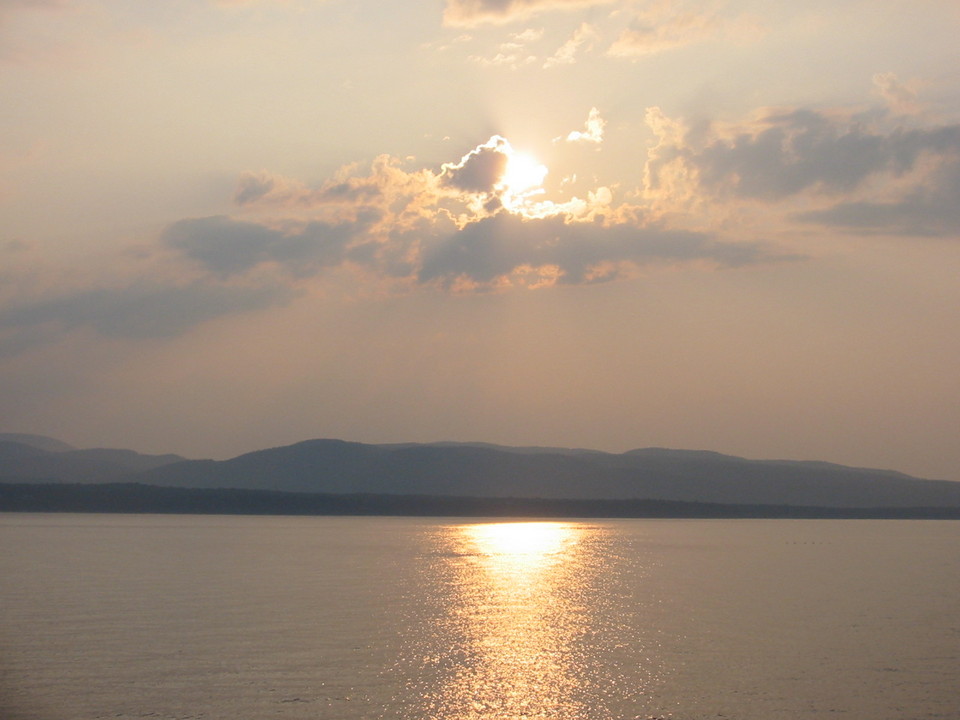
[{"left": 164, "top": 205, "right": 773, "bottom": 287}]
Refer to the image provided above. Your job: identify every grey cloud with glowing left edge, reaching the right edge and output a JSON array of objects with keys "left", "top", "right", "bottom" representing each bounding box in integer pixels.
[{"left": 645, "top": 103, "right": 960, "bottom": 236}]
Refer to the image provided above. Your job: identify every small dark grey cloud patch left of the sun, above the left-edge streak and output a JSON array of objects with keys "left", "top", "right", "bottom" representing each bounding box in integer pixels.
[{"left": 162, "top": 212, "right": 376, "bottom": 276}]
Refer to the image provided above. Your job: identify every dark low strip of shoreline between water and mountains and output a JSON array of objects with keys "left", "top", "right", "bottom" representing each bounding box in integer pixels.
[{"left": 0, "top": 482, "right": 960, "bottom": 520}]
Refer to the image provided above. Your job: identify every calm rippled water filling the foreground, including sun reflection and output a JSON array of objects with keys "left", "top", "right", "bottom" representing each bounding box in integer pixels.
[{"left": 0, "top": 514, "right": 960, "bottom": 720}]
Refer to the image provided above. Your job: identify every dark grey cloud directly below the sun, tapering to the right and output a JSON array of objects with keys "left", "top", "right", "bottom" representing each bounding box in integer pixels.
[{"left": 419, "top": 212, "right": 773, "bottom": 286}]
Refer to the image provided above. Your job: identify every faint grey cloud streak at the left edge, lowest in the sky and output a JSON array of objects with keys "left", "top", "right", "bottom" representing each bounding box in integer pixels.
[{"left": 0, "top": 281, "right": 294, "bottom": 350}]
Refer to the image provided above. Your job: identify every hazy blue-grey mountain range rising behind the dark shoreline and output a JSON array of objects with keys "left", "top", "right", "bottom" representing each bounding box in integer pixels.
[{"left": 0, "top": 433, "right": 960, "bottom": 508}]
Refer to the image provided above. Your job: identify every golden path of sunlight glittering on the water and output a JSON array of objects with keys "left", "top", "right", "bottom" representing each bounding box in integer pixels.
[{"left": 410, "top": 522, "right": 612, "bottom": 720}]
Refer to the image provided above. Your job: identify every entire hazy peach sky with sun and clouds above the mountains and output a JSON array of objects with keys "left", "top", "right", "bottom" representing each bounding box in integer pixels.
[{"left": 0, "top": 0, "right": 960, "bottom": 480}]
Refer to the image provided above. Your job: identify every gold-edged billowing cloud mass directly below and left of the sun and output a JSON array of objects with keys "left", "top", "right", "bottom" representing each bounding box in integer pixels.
[{"left": 162, "top": 132, "right": 792, "bottom": 290}]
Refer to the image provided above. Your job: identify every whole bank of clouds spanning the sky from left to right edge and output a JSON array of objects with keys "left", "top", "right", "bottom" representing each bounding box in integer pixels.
[{"left": 24, "top": 95, "right": 960, "bottom": 352}]
